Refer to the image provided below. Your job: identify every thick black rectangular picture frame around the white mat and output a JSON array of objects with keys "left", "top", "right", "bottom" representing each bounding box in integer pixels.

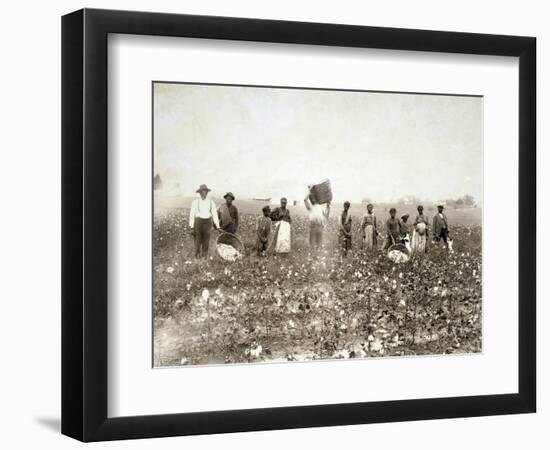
[{"left": 62, "top": 9, "right": 536, "bottom": 441}]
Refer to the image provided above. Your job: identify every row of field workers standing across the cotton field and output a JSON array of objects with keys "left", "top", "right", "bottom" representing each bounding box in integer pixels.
[{"left": 189, "top": 184, "right": 452, "bottom": 258}]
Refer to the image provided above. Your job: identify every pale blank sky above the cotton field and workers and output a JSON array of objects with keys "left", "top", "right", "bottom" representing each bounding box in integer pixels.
[{"left": 154, "top": 83, "right": 483, "bottom": 204}]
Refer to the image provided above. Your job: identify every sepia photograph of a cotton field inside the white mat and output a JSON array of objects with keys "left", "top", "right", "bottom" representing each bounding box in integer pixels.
[{"left": 152, "top": 81, "right": 483, "bottom": 367}]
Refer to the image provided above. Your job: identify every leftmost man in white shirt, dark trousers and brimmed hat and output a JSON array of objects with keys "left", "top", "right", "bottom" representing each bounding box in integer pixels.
[{"left": 189, "top": 184, "right": 220, "bottom": 258}]
